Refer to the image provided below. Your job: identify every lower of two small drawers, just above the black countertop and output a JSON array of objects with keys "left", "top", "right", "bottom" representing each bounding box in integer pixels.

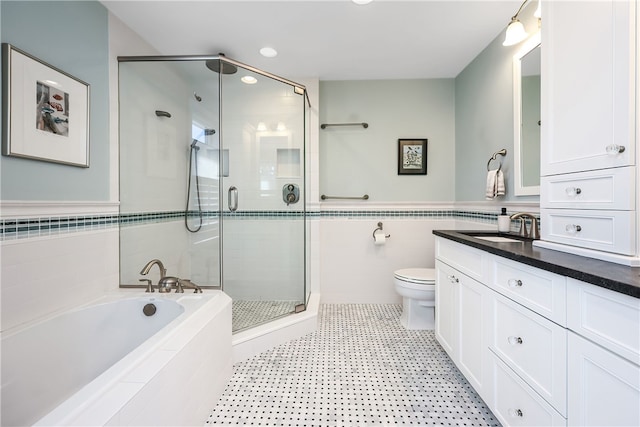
[{"left": 540, "top": 209, "right": 636, "bottom": 255}]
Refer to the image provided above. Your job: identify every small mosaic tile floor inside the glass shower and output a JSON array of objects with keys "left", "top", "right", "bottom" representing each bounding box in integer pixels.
[{"left": 231, "top": 300, "right": 302, "bottom": 332}]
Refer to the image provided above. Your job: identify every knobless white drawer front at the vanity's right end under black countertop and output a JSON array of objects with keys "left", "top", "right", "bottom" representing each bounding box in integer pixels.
[{"left": 567, "top": 278, "right": 640, "bottom": 365}]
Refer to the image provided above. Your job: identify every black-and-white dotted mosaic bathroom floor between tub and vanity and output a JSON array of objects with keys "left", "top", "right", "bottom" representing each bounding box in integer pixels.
[{"left": 205, "top": 304, "right": 499, "bottom": 426}]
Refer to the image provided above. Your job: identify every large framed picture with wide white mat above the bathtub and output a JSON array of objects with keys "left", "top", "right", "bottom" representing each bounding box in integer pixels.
[{"left": 2, "top": 43, "right": 89, "bottom": 168}]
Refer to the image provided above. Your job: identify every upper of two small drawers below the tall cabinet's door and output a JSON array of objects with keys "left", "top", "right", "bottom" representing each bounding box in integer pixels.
[{"left": 540, "top": 167, "right": 636, "bottom": 210}]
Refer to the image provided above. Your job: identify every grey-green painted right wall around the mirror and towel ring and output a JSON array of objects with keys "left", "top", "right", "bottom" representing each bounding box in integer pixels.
[{"left": 455, "top": 2, "right": 539, "bottom": 205}]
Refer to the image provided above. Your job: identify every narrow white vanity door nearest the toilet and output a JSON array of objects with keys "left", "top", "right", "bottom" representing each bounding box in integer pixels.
[{"left": 436, "top": 260, "right": 460, "bottom": 361}]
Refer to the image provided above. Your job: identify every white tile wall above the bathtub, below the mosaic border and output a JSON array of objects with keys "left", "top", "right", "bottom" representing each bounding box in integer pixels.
[{"left": 0, "top": 228, "right": 118, "bottom": 332}]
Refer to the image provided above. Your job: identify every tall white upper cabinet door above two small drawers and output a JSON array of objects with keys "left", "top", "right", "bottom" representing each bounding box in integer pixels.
[{"left": 540, "top": 0, "right": 636, "bottom": 176}]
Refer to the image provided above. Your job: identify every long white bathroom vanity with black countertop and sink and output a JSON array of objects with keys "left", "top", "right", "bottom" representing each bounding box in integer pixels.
[{"left": 433, "top": 230, "right": 640, "bottom": 426}]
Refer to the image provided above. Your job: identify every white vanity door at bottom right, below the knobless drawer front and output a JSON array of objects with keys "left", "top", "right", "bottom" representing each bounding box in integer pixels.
[{"left": 568, "top": 332, "right": 640, "bottom": 426}]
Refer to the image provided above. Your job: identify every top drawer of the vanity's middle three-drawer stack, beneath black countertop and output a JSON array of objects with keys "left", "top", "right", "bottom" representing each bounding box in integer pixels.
[{"left": 489, "top": 256, "right": 567, "bottom": 326}]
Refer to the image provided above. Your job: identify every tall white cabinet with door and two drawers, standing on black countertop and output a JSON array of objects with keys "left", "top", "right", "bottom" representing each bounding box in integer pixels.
[{"left": 540, "top": 0, "right": 640, "bottom": 265}]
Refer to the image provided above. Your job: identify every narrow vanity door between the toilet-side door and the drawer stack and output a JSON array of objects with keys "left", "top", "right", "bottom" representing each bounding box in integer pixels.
[{"left": 456, "top": 275, "right": 491, "bottom": 395}]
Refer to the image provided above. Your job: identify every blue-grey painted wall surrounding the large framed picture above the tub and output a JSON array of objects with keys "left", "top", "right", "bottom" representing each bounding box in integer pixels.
[{"left": 0, "top": 1, "right": 109, "bottom": 201}]
